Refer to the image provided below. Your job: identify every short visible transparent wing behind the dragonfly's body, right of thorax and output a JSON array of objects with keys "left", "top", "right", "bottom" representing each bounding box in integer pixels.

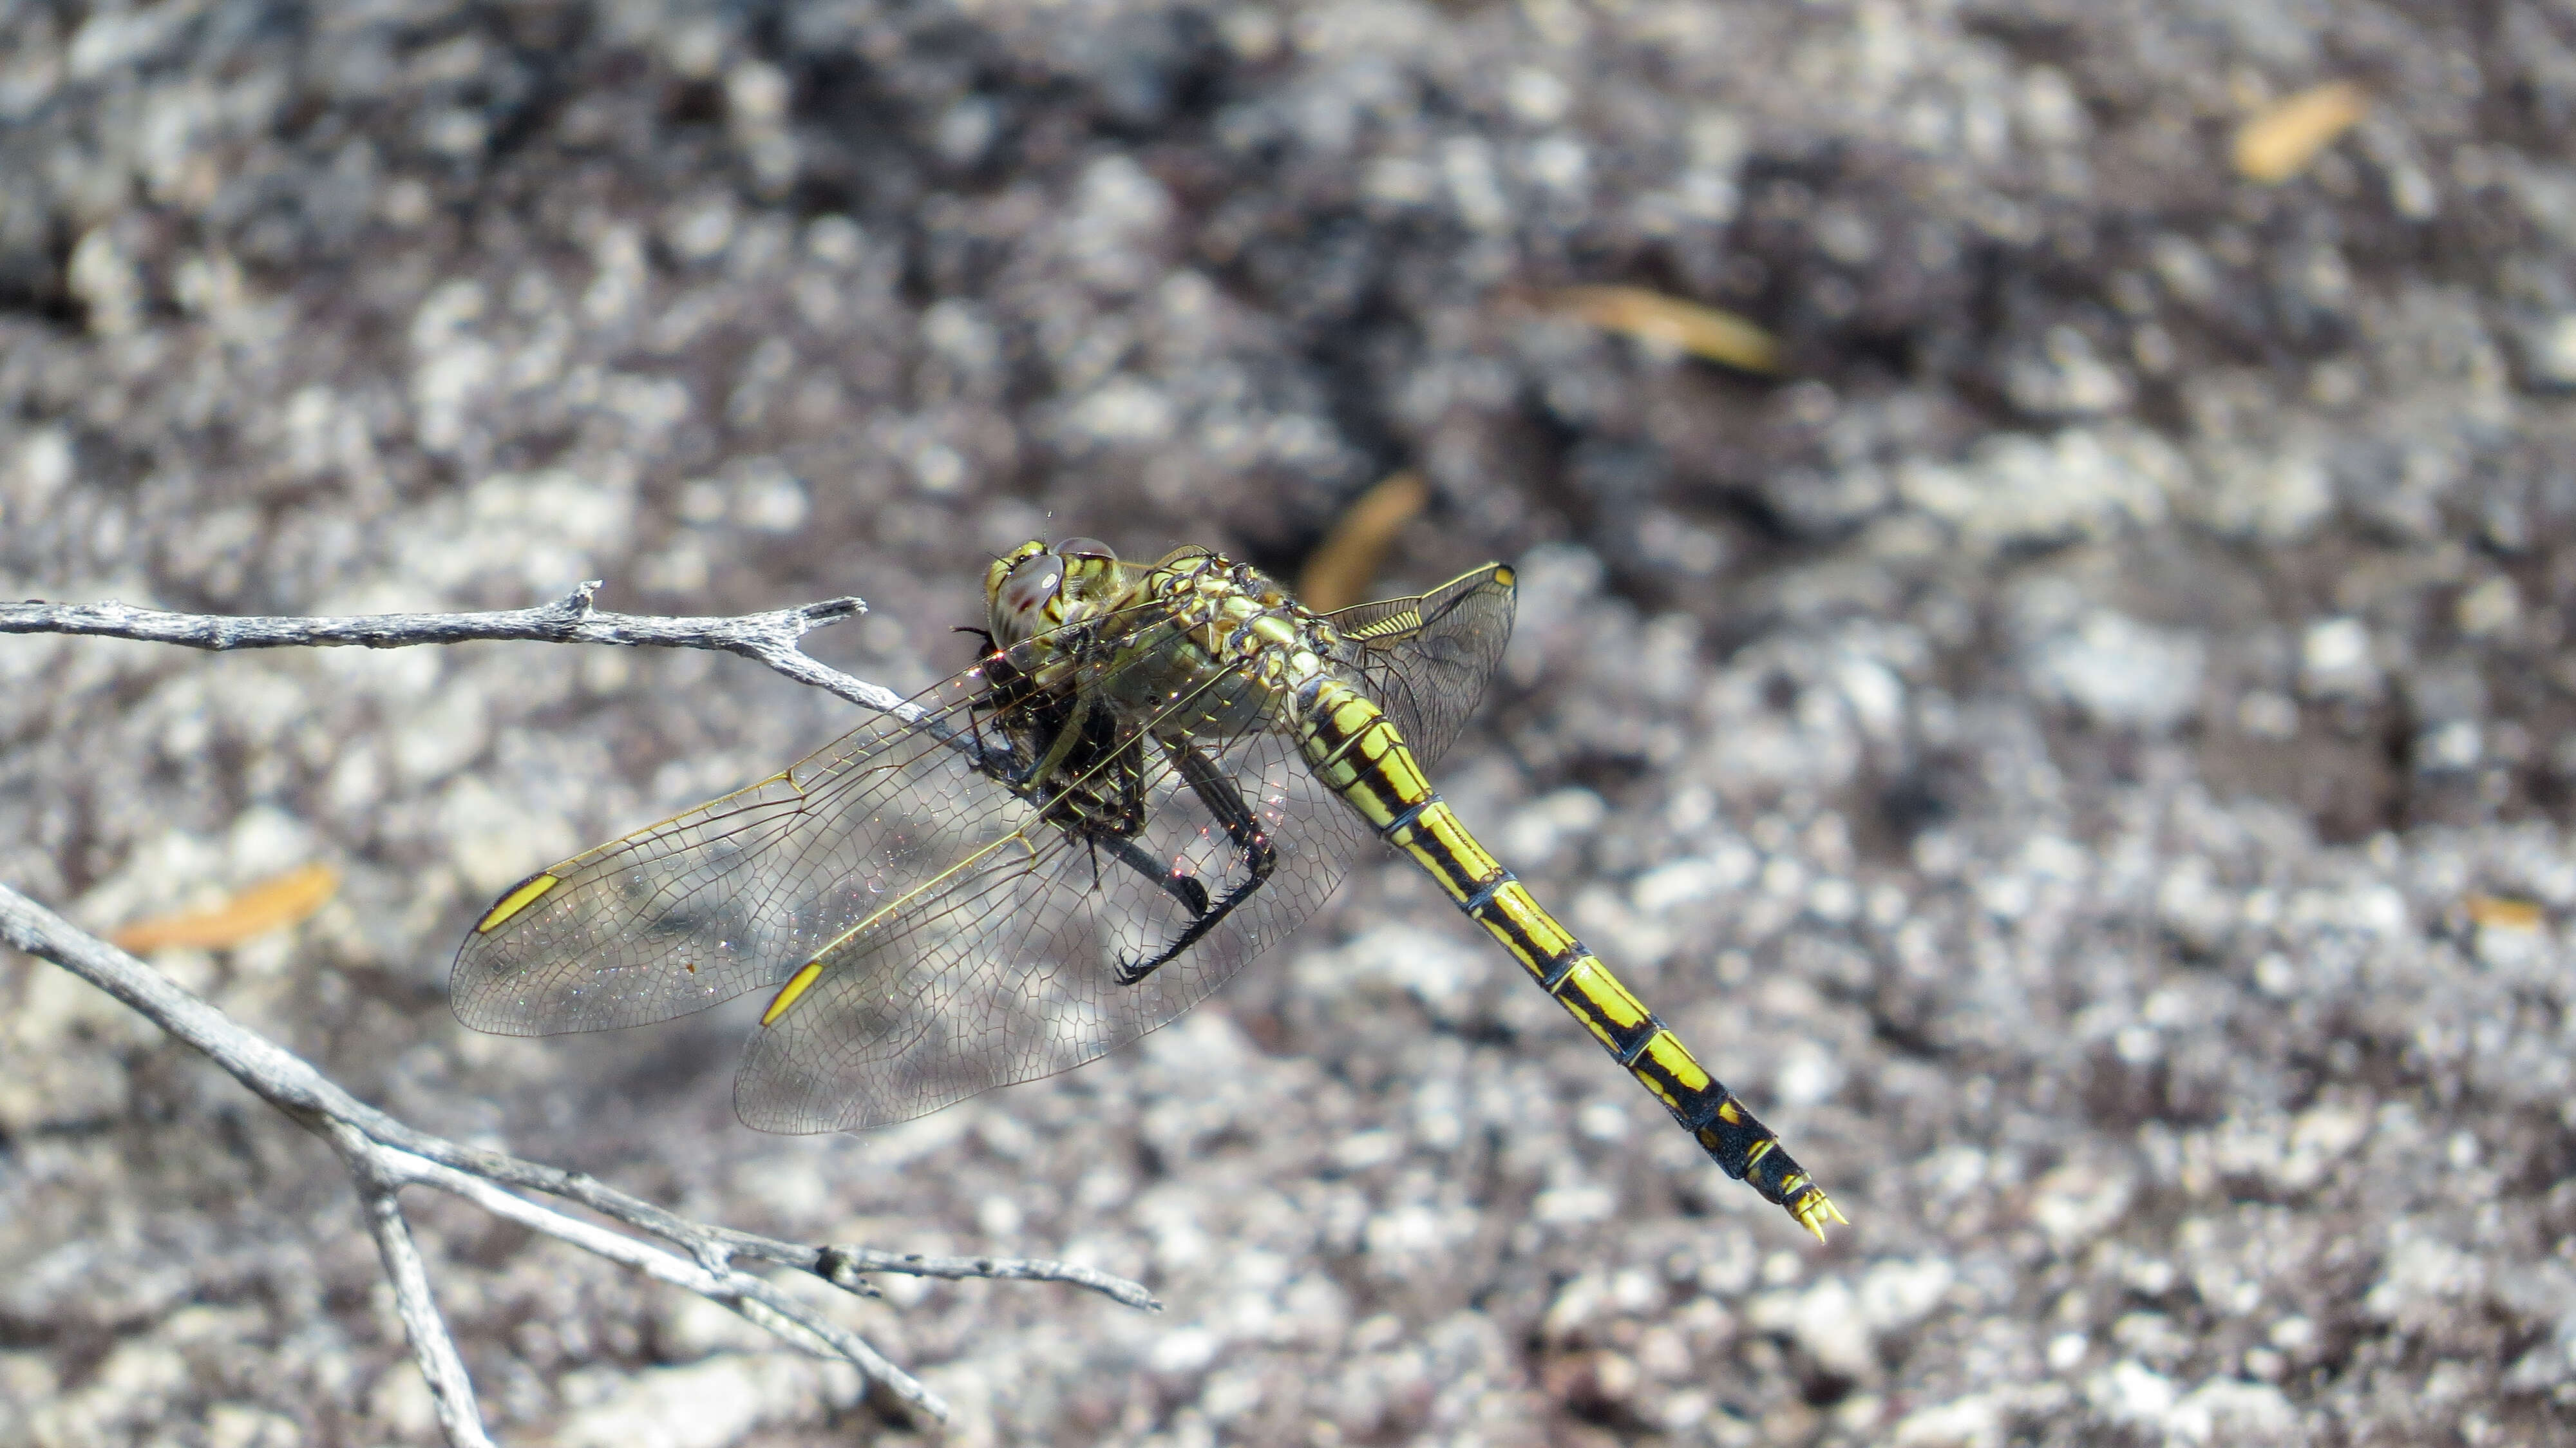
[{"left": 1327, "top": 564, "right": 1517, "bottom": 768}]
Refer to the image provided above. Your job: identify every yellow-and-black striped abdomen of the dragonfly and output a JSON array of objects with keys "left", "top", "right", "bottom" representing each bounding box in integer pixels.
[{"left": 1298, "top": 678, "right": 1844, "bottom": 1239}]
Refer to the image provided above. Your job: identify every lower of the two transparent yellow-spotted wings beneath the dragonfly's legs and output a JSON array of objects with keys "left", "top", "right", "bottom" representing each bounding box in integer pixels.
[{"left": 734, "top": 706, "right": 1370, "bottom": 1131}]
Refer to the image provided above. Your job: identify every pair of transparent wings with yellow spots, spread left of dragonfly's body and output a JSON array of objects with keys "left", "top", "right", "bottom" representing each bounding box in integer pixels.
[{"left": 453, "top": 631, "right": 1370, "bottom": 1131}]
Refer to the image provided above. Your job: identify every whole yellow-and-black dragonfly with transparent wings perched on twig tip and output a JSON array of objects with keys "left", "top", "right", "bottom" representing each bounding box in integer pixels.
[{"left": 451, "top": 538, "right": 1847, "bottom": 1239}]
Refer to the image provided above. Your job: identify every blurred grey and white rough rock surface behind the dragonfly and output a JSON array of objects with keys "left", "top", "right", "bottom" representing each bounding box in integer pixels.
[{"left": 0, "top": 0, "right": 2576, "bottom": 1448}]
